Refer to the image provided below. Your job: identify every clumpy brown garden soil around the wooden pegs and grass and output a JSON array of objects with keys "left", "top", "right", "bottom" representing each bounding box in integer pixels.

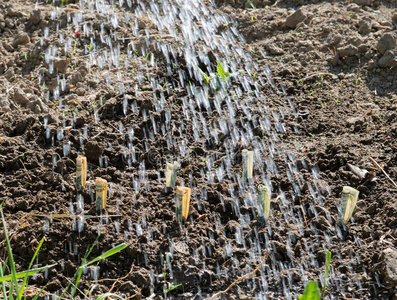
[{"left": 0, "top": 0, "right": 397, "bottom": 299}]
